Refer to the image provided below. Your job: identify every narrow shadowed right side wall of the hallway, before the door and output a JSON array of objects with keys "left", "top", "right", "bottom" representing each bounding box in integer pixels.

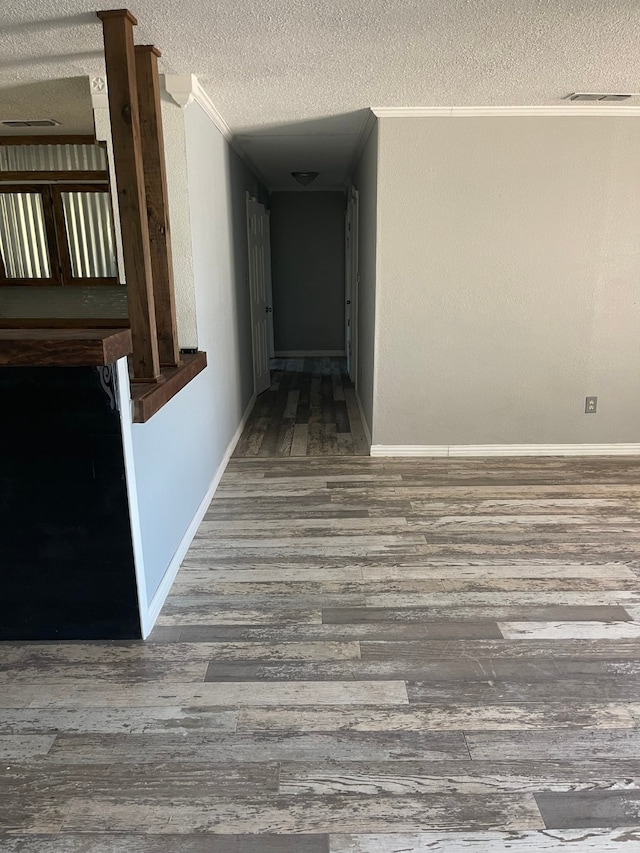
[{"left": 353, "top": 123, "right": 378, "bottom": 442}]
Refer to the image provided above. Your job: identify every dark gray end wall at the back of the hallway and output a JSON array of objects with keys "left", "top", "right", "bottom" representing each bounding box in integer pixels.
[{"left": 269, "top": 191, "right": 345, "bottom": 352}]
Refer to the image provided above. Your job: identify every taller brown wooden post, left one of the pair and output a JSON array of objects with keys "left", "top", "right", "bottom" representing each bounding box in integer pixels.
[{"left": 97, "top": 9, "right": 160, "bottom": 382}]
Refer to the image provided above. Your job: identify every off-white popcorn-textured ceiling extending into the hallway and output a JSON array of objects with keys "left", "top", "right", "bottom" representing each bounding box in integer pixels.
[{"left": 0, "top": 0, "right": 640, "bottom": 186}]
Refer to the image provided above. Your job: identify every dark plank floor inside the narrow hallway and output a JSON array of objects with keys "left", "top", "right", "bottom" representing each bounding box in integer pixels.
[{"left": 233, "top": 358, "right": 369, "bottom": 457}]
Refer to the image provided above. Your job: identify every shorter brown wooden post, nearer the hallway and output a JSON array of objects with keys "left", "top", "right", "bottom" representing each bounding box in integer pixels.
[{"left": 135, "top": 45, "right": 180, "bottom": 367}]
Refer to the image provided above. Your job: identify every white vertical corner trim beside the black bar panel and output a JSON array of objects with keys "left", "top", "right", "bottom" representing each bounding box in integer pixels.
[{"left": 116, "top": 358, "right": 147, "bottom": 637}]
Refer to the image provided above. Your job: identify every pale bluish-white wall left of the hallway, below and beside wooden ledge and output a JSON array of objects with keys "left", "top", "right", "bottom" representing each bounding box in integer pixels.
[{"left": 129, "top": 103, "right": 259, "bottom": 612}]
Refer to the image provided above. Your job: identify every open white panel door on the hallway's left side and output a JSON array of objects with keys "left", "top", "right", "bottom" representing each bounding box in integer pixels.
[{"left": 247, "top": 193, "right": 271, "bottom": 394}]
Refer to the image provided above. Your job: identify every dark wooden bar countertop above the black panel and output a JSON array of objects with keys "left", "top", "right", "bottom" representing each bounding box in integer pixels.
[{"left": 0, "top": 329, "right": 133, "bottom": 367}]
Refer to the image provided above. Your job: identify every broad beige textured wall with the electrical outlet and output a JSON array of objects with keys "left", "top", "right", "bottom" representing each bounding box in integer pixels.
[{"left": 376, "top": 117, "right": 640, "bottom": 446}]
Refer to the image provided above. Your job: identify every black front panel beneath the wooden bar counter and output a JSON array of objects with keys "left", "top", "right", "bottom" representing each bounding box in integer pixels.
[{"left": 0, "top": 367, "right": 141, "bottom": 640}]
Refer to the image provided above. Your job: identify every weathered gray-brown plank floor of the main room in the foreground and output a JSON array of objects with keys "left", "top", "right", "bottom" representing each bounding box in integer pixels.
[{"left": 0, "top": 456, "right": 640, "bottom": 853}]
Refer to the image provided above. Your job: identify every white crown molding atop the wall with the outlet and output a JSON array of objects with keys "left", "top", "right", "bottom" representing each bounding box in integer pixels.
[{"left": 371, "top": 102, "right": 640, "bottom": 118}]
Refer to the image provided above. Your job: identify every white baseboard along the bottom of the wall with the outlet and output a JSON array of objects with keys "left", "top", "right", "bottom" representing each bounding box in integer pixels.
[{"left": 371, "top": 444, "right": 640, "bottom": 457}]
